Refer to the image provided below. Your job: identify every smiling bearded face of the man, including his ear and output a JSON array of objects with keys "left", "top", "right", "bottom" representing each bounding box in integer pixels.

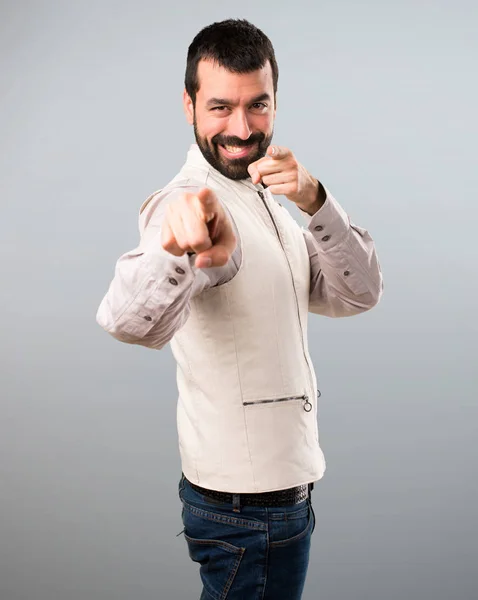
[{"left": 184, "top": 60, "right": 275, "bottom": 179}]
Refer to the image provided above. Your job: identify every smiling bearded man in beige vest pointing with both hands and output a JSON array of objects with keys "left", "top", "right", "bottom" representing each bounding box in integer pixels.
[{"left": 97, "top": 20, "right": 382, "bottom": 600}]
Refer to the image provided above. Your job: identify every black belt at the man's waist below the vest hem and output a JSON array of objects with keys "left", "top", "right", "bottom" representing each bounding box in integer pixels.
[{"left": 187, "top": 479, "right": 314, "bottom": 506}]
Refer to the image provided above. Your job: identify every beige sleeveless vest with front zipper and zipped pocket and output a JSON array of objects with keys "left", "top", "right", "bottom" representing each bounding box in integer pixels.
[{"left": 163, "top": 145, "right": 325, "bottom": 493}]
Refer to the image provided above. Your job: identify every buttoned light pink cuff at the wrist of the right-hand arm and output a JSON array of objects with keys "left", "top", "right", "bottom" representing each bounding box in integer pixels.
[{"left": 299, "top": 187, "right": 350, "bottom": 251}]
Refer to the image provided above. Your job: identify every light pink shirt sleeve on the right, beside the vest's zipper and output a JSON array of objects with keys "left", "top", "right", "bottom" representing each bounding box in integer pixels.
[{"left": 301, "top": 189, "right": 383, "bottom": 317}]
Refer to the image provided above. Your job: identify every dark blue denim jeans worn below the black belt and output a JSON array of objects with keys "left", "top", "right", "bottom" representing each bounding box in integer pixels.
[{"left": 179, "top": 476, "right": 315, "bottom": 600}]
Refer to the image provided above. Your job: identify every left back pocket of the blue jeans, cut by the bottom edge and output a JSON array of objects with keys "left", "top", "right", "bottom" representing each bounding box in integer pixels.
[{"left": 184, "top": 533, "right": 245, "bottom": 600}]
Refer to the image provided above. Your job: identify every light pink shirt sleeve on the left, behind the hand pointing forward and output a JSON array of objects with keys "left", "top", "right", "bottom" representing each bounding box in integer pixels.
[{"left": 96, "top": 187, "right": 241, "bottom": 349}]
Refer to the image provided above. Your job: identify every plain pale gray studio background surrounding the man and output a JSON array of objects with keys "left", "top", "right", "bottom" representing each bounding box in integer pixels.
[{"left": 0, "top": 0, "right": 478, "bottom": 600}]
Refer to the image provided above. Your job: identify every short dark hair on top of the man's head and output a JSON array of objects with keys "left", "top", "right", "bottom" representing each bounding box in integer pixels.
[{"left": 184, "top": 19, "right": 279, "bottom": 103}]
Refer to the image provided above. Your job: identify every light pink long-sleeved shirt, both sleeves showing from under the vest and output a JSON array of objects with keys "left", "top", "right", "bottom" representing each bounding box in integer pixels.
[{"left": 96, "top": 186, "right": 383, "bottom": 349}]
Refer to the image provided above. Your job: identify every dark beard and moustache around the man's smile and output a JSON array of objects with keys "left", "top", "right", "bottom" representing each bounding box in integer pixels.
[{"left": 194, "top": 115, "right": 273, "bottom": 181}]
